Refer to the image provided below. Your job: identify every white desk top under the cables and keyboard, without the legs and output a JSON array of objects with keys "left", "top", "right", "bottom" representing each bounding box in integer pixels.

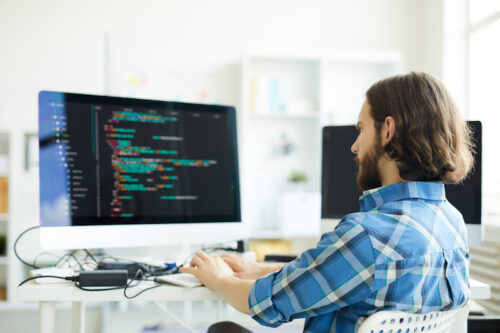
[{"left": 18, "top": 279, "right": 491, "bottom": 302}]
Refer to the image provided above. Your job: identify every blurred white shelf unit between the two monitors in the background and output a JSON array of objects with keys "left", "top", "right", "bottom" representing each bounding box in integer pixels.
[{"left": 238, "top": 50, "right": 402, "bottom": 238}]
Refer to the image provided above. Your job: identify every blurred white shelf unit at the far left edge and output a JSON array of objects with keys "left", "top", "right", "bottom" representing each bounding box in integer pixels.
[{"left": 0, "top": 127, "right": 38, "bottom": 310}]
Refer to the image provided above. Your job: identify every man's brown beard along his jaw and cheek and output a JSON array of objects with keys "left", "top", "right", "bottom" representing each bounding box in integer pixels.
[{"left": 354, "top": 138, "right": 383, "bottom": 191}]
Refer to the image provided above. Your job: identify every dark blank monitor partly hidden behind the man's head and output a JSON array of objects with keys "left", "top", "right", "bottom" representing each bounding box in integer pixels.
[{"left": 321, "top": 121, "right": 482, "bottom": 244}]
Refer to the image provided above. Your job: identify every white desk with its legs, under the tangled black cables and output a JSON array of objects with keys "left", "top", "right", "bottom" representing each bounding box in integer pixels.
[{"left": 18, "top": 279, "right": 491, "bottom": 333}]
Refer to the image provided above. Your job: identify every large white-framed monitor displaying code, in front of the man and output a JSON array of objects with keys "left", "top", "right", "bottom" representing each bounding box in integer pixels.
[{"left": 39, "top": 91, "right": 244, "bottom": 249}]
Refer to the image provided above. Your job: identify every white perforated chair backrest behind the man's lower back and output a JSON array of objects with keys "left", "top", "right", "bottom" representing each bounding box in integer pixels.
[{"left": 357, "top": 303, "right": 469, "bottom": 333}]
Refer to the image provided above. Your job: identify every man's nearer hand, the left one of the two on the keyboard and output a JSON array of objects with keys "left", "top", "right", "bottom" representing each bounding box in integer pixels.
[{"left": 179, "top": 251, "right": 234, "bottom": 290}]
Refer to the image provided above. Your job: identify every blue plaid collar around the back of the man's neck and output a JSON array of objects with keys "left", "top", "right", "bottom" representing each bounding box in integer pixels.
[{"left": 359, "top": 182, "right": 446, "bottom": 212}]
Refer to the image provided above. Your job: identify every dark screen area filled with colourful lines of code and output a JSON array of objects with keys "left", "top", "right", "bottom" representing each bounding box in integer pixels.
[{"left": 41, "top": 101, "right": 239, "bottom": 225}]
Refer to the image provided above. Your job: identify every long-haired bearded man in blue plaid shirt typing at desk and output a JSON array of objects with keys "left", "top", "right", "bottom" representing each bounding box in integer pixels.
[{"left": 181, "top": 72, "right": 473, "bottom": 332}]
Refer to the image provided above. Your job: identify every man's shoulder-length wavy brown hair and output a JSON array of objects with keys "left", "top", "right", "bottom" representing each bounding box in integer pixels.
[{"left": 366, "top": 72, "right": 474, "bottom": 184}]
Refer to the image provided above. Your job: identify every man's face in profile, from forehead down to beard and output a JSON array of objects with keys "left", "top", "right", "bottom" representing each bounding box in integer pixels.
[{"left": 351, "top": 100, "right": 383, "bottom": 191}]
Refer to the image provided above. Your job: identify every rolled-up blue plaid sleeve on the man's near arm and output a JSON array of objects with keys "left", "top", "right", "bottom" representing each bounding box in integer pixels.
[{"left": 248, "top": 218, "right": 375, "bottom": 327}]
